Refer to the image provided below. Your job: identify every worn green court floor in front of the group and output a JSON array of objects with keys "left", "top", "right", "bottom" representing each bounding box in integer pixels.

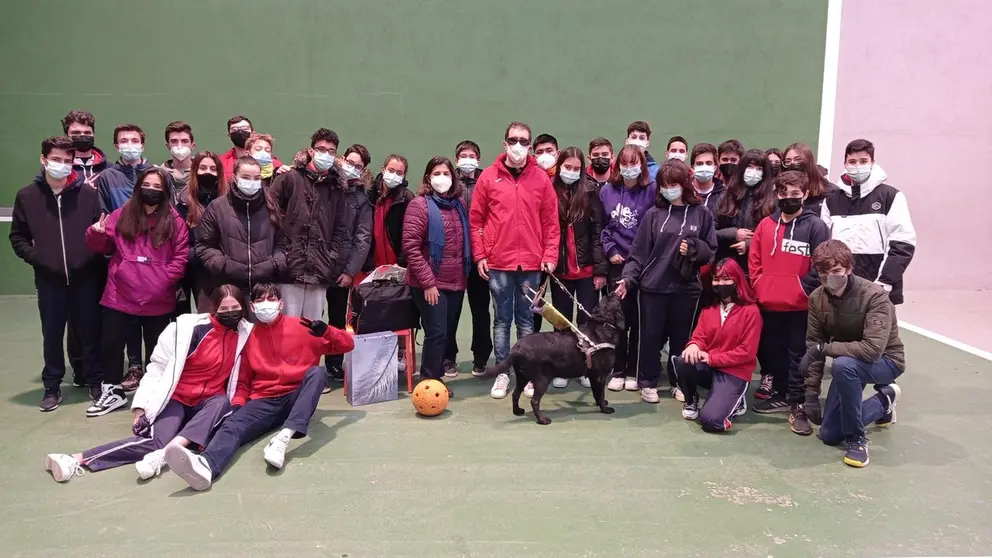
[{"left": 0, "top": 297, "right": 992, "bottom": 558}]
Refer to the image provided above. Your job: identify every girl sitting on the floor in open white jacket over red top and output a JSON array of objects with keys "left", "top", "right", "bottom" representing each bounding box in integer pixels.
[{"left": 45, "top": 285, "right": 252, "bottom": 482}]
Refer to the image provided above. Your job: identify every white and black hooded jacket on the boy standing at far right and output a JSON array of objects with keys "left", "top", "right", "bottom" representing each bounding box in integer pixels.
[{"left": 820, "top": 165, "right": 916, "bottom": 304}]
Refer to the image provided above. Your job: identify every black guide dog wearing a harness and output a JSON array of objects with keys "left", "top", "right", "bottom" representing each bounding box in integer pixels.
[{"left": 491, "top": 295, "right": 624, "bottom": 424}]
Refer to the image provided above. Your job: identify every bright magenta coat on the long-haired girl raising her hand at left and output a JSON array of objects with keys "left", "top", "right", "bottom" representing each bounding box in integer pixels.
[{"left": 86, "top": 206, "right": 189, "bottom": 316}]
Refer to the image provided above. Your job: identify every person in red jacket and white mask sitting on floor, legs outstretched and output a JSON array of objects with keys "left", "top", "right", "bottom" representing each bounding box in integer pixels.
[{"left": 165, "top": 283, "right": 355, "bottom": 490}]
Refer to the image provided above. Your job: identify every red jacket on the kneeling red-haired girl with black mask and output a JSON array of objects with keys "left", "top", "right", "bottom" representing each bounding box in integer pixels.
[{"left": 687, "top": 304, "right": 761, "bottom": 382}]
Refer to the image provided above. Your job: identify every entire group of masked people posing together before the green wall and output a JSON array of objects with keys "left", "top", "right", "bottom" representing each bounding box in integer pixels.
[{"left": 10, "top": 111, "right": 915, "bottom": 482}]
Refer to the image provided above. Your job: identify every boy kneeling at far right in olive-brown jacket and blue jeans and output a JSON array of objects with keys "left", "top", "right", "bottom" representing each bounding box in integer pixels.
[{"left": 801, "top": 240, "right": 906, "bottom": 467}]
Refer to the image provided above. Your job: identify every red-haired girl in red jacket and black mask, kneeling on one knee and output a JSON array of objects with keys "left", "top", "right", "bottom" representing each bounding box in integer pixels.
[{"left": 672, "top": 258, "right": 762, "bottom": 432}]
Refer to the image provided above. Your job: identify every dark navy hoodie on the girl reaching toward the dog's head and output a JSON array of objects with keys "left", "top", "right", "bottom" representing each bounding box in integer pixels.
[{"left": 622, "top": 205, "right": 716, "bottom": 295}]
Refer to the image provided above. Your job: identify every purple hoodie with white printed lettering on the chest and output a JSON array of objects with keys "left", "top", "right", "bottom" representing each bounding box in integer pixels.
[{"left": 599, "top": 180, "right": 658, "bottom": 259}]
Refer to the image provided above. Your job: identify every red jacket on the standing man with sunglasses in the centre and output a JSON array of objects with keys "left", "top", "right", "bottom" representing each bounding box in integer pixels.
[{"left": 468, "top": 153, "right": 561, "bottom": 271}]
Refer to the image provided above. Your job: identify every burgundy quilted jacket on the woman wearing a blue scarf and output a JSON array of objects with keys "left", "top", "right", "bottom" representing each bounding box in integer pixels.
[{"left": 403, "top": 196, "right": 467, "bottom": 291}]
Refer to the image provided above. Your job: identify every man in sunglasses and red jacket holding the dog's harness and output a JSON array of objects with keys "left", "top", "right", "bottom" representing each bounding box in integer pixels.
[{"left": 469, "top": 122, "right": 561, "bottom": 399}]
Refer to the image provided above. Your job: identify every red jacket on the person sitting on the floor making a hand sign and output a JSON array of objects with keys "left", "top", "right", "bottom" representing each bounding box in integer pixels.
[{"left": 231, "top": 316, "right": 355, "bottom": 407}]
